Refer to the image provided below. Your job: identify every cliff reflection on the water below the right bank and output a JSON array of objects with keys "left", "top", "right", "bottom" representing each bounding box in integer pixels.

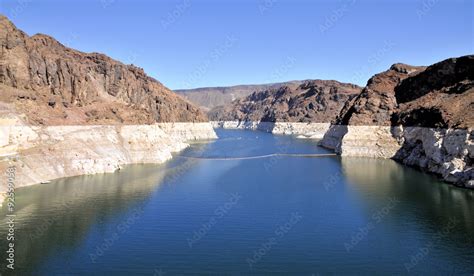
[{"left": 341, "top": 157, "right": 474, "bottom": 245}]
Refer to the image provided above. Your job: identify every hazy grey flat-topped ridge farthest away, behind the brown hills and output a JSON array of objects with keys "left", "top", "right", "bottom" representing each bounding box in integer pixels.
[{"left": 174, "top": 81, "right": 304, "bottom": 111}]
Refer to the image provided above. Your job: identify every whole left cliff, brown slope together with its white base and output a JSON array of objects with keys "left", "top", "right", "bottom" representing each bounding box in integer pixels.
[{"left": 0, "top": 15, "right": 217, "bottom": 199}]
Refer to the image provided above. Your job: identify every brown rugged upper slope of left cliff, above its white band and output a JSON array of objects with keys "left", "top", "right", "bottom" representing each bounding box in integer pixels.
[{"left": 0, "top": 15, "right": 207, "bottom": 125}]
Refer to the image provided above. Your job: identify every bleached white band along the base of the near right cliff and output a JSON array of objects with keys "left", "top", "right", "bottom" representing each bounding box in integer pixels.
[{"left": 321, "top": 126, "right": 474, "bottom": 188}]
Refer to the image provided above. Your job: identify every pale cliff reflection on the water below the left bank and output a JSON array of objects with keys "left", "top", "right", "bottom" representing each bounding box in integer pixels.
[{"left": 0, "top": 156, "right": 200, "bottom": 274}]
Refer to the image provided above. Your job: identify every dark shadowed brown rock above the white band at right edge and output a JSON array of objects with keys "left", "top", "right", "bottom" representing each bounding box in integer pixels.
[{"left": 392, "top": 55, "right": 474, "bottom": 128}]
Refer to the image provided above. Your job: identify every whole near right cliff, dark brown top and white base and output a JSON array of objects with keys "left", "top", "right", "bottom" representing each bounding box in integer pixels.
[{"left": 322, "top": 56, "right": 474, "bottom": 190}]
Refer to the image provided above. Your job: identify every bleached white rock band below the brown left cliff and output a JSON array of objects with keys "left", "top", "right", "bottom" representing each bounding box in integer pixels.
[{"left": 0, "top": 120, "right": 217, "bottom": 192}]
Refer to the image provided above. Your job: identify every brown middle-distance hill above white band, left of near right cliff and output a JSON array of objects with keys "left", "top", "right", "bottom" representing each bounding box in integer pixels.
[{"left": 209, "top": 80, "right": 361, "bottom": 123}]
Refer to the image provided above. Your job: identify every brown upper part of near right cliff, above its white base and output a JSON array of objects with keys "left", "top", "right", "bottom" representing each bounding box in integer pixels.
[{"left": 337, "top": 56, "right": 474, "bottom": 128}]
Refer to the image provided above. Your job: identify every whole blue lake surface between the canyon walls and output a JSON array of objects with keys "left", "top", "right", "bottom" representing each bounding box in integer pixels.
[{"left": 0, "top": 130, "right": 474, "bottom": 275}]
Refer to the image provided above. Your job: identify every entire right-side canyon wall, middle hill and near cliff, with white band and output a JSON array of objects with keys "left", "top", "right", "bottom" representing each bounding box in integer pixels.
[{"left": 210, "top": 55, "right": 474, "bottom": 188}]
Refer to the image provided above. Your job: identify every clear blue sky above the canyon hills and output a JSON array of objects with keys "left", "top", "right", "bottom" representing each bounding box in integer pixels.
[{"left": 0, "top": 0, "right": 474, "bottom": 89}]
